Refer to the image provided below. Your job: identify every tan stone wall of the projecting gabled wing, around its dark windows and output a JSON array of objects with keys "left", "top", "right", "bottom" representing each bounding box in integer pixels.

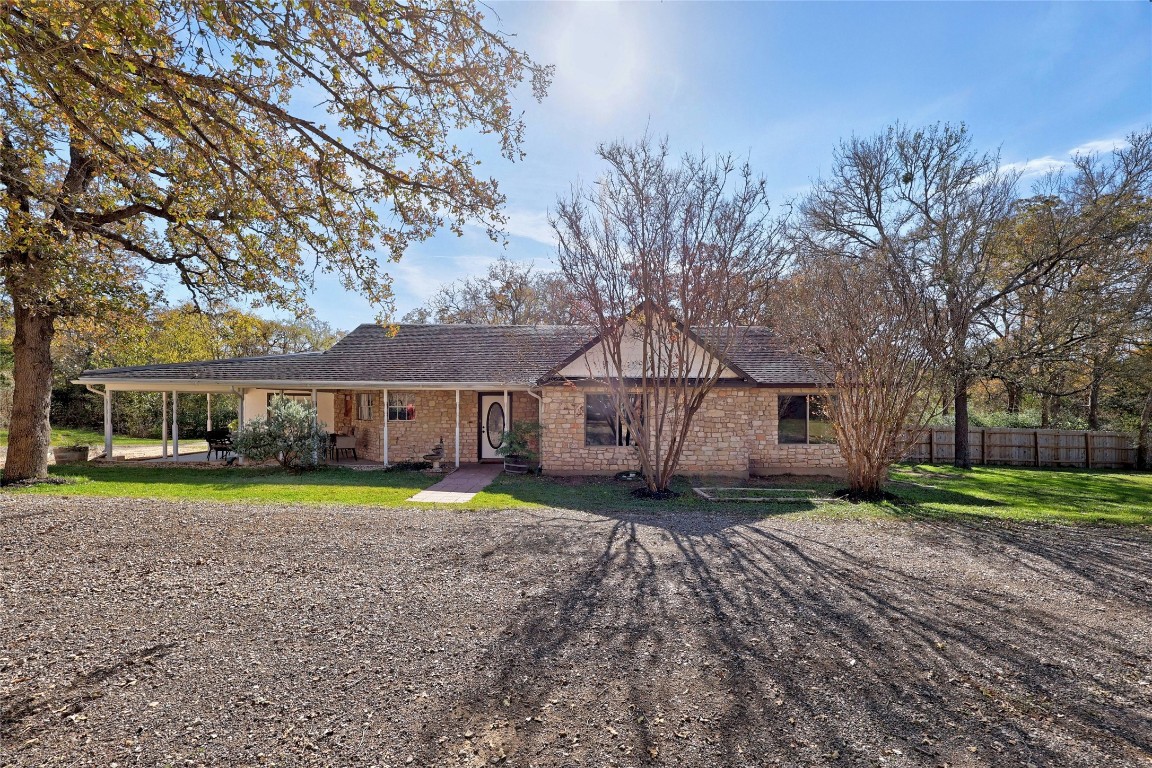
[{"left": 541, "top": 387, "right": 843, "bottom": 477}]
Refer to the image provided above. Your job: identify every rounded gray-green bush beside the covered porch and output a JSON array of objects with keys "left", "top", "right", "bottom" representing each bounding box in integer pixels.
[{"left": 233, "top": 396, "right": 328, "bottom": 472}]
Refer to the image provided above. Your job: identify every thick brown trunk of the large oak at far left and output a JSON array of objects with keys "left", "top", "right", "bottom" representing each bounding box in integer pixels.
[{"left": 2, "top": 297, "right": 55, "bottom": 485}]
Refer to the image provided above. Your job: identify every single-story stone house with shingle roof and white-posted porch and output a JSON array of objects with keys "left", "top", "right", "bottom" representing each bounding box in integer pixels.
[{"left": 77, "top": 325, "right": 842, "bottom": 477}]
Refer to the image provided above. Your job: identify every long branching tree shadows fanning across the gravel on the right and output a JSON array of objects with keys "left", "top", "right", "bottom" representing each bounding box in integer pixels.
[{"left": 418, "top": 515, "right": 1152, "bottom": 767}]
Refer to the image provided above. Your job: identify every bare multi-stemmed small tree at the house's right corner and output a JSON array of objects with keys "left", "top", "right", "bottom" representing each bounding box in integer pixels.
[{"left": 778, "top": 254, "right": 943, "bottom": 500}]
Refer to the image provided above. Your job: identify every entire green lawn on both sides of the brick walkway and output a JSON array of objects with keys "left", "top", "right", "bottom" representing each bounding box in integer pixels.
[{"left": 10, "top": 465, "right": 1152, "bottom": 525}]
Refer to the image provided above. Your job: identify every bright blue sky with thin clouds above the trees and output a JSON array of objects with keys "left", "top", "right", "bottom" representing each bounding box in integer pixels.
[{"left": 299, "top": 2, "right": 1152, "bottom": 329}]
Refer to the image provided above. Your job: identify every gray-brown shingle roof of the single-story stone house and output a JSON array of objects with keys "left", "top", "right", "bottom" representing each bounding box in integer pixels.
[{"left": 81, "top": 324, "right": 816, "bottom": 386}]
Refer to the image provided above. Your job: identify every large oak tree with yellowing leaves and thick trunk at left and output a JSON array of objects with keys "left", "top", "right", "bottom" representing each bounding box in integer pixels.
[{"left": 0, "top": 0, "right": 548, "bottom": 481}]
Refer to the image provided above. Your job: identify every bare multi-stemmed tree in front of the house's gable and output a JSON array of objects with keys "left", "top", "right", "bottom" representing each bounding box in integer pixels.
[{"left": 552, "top": 137, "right": 782, "bottom": 494}]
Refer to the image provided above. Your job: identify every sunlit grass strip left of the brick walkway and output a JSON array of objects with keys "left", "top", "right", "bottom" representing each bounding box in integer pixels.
[{"left": 12, "top": 464, "right": 437, "bottom": 507}]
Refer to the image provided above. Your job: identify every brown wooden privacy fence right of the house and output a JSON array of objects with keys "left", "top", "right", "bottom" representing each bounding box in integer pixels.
[{"left": 904, "top": 427, "right": 1136, "bottom": 469}]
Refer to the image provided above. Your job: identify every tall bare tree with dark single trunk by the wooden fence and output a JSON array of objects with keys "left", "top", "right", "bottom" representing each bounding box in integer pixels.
[{"left": 802, "top": 124, "right": 1152, "bottom": 467}]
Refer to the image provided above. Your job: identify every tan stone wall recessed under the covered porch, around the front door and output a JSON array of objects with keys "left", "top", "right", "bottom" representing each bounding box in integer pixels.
[{"left": 333, "top": 389, "right": 539, "bottom": 464}]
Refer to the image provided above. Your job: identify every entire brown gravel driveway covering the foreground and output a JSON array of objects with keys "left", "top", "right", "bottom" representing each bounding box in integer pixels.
[{"left": 0, "top": 494, "right": 1152, "bottom": 768}]
